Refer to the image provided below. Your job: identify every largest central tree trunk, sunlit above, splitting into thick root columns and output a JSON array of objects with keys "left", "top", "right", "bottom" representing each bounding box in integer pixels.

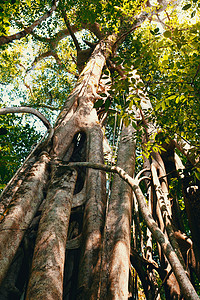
[{"left": 1, "top": 35, "right": 115, "bottom": 299}]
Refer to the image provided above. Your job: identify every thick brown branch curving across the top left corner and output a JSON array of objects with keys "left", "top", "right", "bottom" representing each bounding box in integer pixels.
[{"left": 0, "top": 0, "right": 57, "bottom": 46}]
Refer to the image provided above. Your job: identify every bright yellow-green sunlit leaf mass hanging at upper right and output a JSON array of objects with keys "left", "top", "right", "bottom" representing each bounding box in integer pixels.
[{"left": 109, "top": 9, "right": 200, "bottom": 155}]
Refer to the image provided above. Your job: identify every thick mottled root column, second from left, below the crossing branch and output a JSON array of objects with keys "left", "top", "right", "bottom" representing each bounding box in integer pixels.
[{"left": 26, "top": 166, "right": 76, "bottom": 300}]
